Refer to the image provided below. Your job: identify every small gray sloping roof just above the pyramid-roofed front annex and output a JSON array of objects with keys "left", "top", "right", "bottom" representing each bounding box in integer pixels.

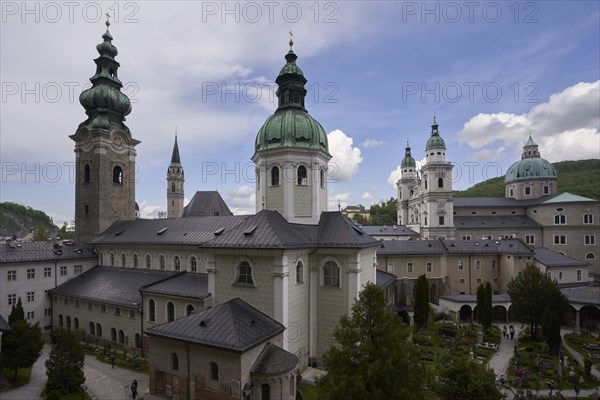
[{"left": 140, "top": 272, "right": 210, "bottom": 299}]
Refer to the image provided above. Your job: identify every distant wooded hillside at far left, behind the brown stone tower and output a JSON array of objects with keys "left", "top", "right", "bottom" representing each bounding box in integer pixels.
[{"left": 0, "top": 202, "right": 58, "bottom": 237}]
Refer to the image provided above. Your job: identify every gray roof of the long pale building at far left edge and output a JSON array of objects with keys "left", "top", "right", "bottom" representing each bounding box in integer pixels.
[{"left": 0, "top": 241, "right": 97, "bottom": 264}]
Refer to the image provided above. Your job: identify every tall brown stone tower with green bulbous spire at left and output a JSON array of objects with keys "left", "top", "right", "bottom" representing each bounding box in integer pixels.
[{"left": 70, "top": 21, "right": 140, "bottom": 241}]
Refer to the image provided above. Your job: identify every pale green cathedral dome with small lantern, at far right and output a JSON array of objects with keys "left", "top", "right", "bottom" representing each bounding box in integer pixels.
[{"left": 504, "top": 135, "right": 558, "bottom": 183}]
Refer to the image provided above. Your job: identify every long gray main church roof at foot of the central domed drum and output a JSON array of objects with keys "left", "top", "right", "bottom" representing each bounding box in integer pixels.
[{"left": 92, "top": 210, "right": 379, "bottom": 249}]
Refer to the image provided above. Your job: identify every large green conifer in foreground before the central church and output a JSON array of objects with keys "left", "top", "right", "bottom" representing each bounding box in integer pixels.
[{"left": 317, "top": 283, "right": 423, "bottom": 400}]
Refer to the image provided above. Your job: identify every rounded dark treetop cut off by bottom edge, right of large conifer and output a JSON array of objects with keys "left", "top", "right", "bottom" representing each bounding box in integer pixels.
[{"left": 435, "top": 357, "right": 504, "bottom": 400}]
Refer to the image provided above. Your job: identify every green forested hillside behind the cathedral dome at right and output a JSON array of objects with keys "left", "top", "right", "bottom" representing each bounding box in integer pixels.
[{"left": 454, "top": 159, "right": 600, "bottom": 200}]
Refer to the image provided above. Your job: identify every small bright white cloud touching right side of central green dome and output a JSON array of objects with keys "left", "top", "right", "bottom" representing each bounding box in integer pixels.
[{"left": 327, "top": 129, "right": 362, "bottom": 182}]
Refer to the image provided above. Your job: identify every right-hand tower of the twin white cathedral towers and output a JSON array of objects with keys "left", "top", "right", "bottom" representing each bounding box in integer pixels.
[{"left": 420, "top": 116, "right": 455, "bottom": 239}]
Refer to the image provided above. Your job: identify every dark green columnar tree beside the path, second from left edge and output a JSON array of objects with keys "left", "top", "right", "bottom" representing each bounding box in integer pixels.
[{"left": 46, "top": 329, "right": 85, "bottom": 394}]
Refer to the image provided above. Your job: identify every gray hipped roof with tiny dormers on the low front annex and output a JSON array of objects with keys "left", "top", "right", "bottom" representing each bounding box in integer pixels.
[{"left": 146, "top": 298, "right": 285, "bottom": 353}]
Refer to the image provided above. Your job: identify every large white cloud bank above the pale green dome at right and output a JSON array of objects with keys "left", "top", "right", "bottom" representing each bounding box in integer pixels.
[{"left": 456, "top": 81, "right": 600, "bottom": 162}]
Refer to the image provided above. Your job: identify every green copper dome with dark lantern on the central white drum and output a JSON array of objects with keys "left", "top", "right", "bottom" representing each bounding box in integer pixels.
[{"left": 255, "top": 40, "right": 329, "bottom": 154}]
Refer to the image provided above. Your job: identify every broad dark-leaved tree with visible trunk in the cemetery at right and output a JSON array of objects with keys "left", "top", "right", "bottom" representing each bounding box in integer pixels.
[{"left": 507, "top": 264, "right": 569, "bottom": 341}]
